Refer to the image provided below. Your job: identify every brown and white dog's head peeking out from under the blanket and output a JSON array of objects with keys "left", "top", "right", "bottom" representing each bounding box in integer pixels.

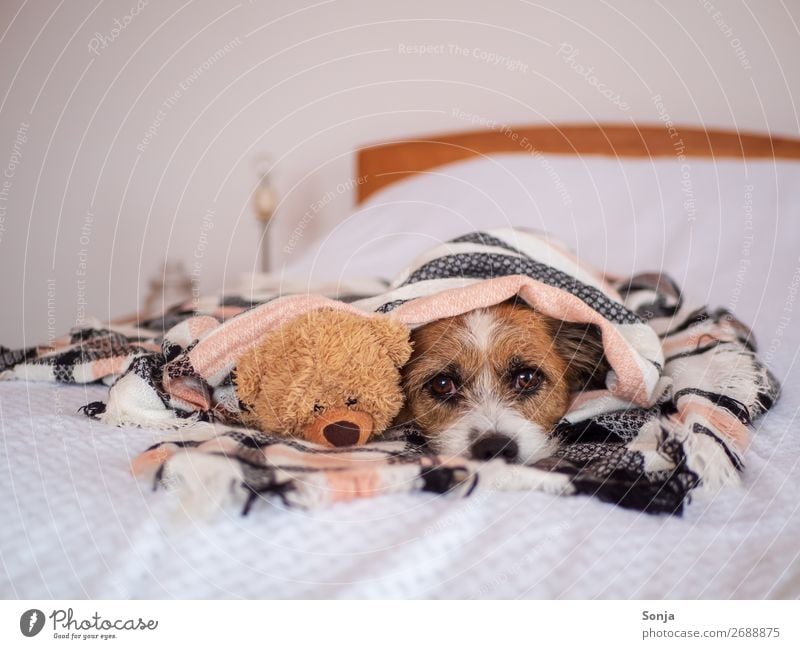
[{"left": 403, "top": 301, "right": 609, "bottom": 464}]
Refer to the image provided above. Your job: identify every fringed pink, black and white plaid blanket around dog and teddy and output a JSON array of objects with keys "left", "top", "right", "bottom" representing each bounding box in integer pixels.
[{"left": 0, "top": 230, "right": 779, "bottom": 513}]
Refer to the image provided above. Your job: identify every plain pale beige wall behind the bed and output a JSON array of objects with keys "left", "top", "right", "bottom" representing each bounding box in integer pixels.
[{"left": 0, "top": 0, "right": 800, "bottom": 346}]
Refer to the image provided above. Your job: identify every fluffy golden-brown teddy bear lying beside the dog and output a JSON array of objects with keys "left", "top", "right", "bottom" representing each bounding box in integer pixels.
[{"left": 235, "top": 309, "right": 411, "bottom": 447}]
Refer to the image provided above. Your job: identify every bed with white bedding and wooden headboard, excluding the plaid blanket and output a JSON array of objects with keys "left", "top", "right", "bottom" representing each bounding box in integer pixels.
[{"left": 0, "top": 125, "right": 800, "bottom": 598}]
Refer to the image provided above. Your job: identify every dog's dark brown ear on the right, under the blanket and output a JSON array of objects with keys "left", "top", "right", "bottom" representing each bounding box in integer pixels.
[{"left": 551, "top": 320, "right": 611, "bottom": 390}]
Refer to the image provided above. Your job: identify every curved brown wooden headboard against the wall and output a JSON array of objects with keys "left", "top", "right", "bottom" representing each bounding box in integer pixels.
[{"left": 357, "top": 125, "right": 800, "bottom": 203}]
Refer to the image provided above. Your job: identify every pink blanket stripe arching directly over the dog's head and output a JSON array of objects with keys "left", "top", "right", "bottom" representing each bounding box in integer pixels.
[{"left": 391, "top": 275, "right": 657, "bottom": 406}]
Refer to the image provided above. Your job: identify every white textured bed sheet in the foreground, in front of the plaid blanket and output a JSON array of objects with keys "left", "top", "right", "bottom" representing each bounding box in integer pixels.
[{"left": 0, "top": 370, "right": 800, "bottom": 598}]
